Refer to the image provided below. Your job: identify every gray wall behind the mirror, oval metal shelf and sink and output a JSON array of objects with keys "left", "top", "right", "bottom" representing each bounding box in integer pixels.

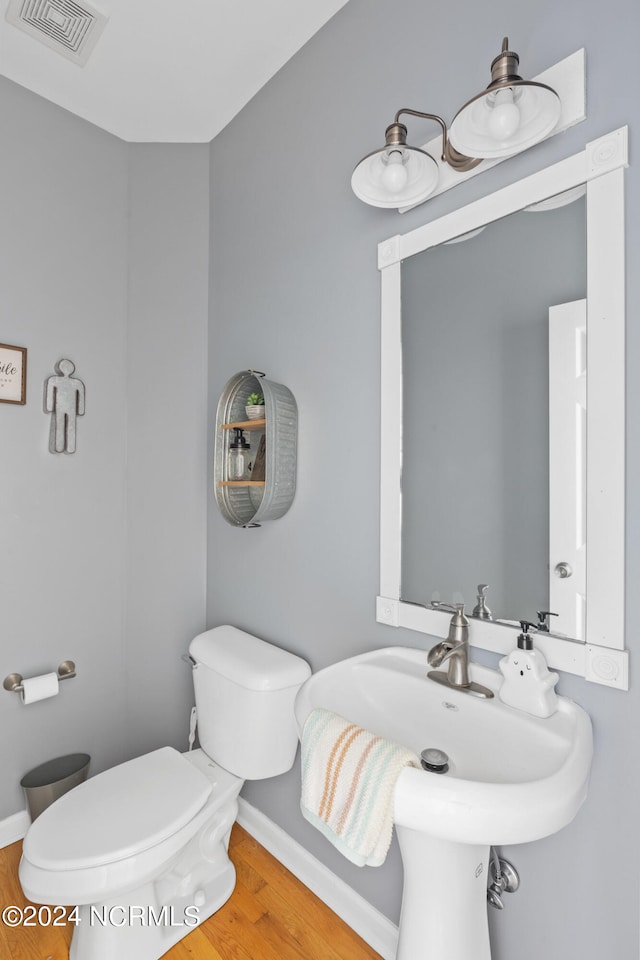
[{"left": 208, "top": 0, "right": 640, "bottom": 960}]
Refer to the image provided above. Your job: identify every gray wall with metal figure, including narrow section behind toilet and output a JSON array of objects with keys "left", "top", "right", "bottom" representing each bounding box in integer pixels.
[{"left": 0, "top": 80, "right": 209, "bottom": 821}]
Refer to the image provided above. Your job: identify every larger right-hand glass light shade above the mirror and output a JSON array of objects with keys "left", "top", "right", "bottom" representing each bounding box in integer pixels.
[{"left": 449, "top": 80, "right": 561, "bottom": 160}]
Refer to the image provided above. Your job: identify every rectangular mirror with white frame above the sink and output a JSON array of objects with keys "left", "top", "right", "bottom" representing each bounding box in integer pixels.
[{"left": 377, "top": 128, "right": 628, "bottom": 688}]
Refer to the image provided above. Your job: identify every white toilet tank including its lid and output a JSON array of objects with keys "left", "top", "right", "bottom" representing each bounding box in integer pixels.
[{"left": 189, "top": 626, "right": 311, "bottom": 780}]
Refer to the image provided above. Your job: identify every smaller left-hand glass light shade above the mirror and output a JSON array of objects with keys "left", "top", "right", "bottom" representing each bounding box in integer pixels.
[{"left": 351, "top": 145, "right": 440, "bottom": 207}]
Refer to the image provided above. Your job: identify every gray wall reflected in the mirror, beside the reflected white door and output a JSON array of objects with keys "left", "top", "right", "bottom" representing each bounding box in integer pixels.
[{"left": 401, "top": 199, "right": 586, "bottom": 636}]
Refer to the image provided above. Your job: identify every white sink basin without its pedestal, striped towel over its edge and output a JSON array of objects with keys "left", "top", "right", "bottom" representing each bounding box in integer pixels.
[{"left": 295, "top": 647, "right": 592, "bottom": 845}]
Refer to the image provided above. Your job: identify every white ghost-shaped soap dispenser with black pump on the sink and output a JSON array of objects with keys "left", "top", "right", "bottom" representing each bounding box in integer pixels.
[{"left": 498, "top": 620, "right": 558, "bottom": 717}]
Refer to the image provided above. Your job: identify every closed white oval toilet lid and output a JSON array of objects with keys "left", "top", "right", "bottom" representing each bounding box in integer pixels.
[{"left": 24, "top": 747, "right": 211, "bottom": 870}]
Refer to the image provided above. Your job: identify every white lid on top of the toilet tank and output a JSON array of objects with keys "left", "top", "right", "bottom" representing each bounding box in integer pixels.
[{"left": 189, "top": 624, "right": 311, "bottom": 691}]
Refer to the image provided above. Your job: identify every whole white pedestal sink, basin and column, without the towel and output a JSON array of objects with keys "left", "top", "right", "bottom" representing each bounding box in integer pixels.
[{"left": 295, "top": 647, "right": 593, "bottom": 960}]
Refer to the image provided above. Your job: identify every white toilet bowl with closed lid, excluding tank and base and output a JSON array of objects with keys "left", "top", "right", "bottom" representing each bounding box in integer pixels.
[{"left": 19, "top": 747, "right": 243, "bottom": 906}]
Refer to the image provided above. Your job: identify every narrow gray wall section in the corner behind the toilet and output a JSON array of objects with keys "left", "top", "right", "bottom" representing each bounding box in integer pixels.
[{"left": 125, "top": 145, "right": 209, "bottom": 756}]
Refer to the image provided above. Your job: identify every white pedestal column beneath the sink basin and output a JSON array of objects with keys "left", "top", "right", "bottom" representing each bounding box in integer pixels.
[{"left": 396, "top": 825, "right": 491, "bottom": 960}]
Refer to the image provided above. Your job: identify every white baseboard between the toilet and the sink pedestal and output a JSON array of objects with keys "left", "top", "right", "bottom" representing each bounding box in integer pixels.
[{"left": 238, "top": 797, "right": 398, "bottom": 960}]
